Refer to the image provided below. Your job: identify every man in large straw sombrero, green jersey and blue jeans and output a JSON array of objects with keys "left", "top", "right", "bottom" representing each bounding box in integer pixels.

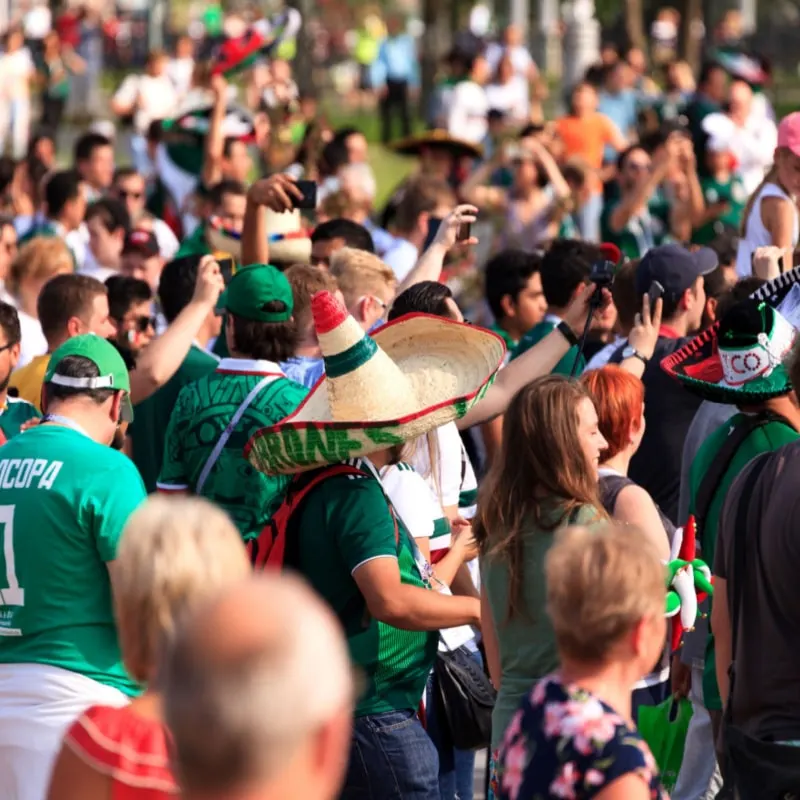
[{"left": 246, "top": 292, "right": 505, "bottom": 798}]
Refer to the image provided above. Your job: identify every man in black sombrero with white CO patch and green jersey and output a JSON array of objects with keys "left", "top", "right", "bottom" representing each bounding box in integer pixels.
[{"left": 662, "top": 299, "right": 800, "bottom": 776}]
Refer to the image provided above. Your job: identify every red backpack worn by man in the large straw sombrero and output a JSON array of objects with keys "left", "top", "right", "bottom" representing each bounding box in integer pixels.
[{"left": 247, "top": 464, "right": 400, "bottom": 570}]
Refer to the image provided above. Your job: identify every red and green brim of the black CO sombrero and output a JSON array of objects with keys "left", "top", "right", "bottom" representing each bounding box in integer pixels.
[{"left": 661, "top": 323, "right": 792, "bottom": 405}]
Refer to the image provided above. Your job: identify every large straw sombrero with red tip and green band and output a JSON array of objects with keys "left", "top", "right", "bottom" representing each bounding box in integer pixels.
[{"left": 245, "top": 292, "right": 505, "bottom": 475}]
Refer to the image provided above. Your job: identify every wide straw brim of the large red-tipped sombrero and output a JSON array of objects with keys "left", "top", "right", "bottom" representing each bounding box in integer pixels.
[{"left": 245, "top": 314, "right": 506, "bottom": 474}]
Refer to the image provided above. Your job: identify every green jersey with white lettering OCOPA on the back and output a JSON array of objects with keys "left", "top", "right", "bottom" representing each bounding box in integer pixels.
[{"left": 0, "top": 425, "right": 145, "bottom": 695}]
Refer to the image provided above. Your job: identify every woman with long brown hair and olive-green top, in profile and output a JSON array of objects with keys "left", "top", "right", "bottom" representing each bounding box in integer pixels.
[{"left": 474, "top": 375, "right": 606, "bottom": 784}]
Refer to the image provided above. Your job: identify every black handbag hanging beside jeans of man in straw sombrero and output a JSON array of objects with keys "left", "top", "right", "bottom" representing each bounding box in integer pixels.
[{"left": 433, "top": 647, "right": 497, "bottom": 750}]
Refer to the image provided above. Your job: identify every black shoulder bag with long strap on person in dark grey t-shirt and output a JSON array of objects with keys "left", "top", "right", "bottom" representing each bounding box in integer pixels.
[{"left": 723, "top": 454, "right": 800, "bottom": 800}]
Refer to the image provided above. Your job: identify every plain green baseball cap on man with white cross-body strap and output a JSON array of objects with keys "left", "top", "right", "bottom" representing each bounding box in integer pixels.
[{"left": 218, "top": 264, "right": 294, "bottom": 322}]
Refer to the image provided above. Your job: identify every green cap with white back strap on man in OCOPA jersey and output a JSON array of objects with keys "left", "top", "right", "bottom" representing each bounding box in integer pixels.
[{"left": 44, "top": 333, "right": 133, "bottom": 422}]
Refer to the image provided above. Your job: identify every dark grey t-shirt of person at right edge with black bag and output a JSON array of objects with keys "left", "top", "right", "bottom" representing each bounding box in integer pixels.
[{"left": 714, "top": 441, "right": 800, "bottom": 741}]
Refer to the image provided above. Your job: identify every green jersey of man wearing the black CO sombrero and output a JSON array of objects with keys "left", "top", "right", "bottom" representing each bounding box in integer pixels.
[{"left": 689, "top": 414, "right": 798, "bottom": 711}]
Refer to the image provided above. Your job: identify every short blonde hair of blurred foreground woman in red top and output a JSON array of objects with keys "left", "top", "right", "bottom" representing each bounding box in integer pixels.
[{"left": 114, "top": 496, "right": 251, "bottom": 683}]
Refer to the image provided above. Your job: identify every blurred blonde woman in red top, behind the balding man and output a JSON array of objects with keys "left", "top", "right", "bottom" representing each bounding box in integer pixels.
[{"left": 47, "top": 497, "right": 251, "bottom": 800}]
